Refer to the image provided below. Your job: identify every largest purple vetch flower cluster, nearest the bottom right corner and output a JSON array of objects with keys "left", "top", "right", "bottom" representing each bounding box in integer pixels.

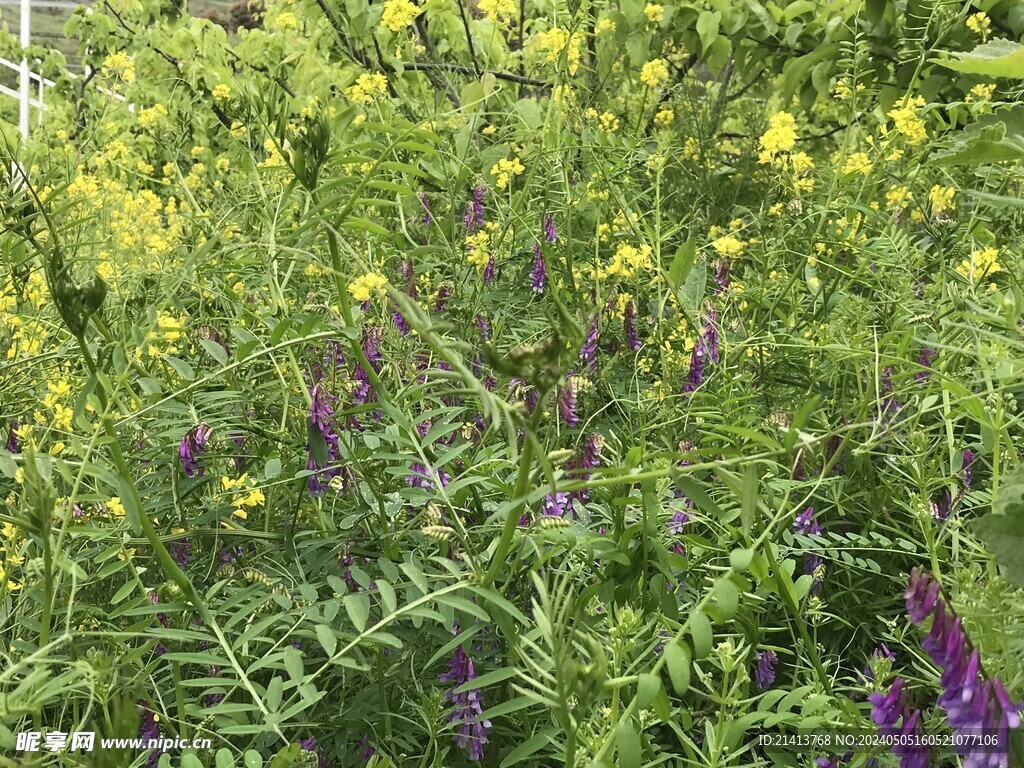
[{"left": 903, "top": 568, "right": 1024, "bottom": 768}]
